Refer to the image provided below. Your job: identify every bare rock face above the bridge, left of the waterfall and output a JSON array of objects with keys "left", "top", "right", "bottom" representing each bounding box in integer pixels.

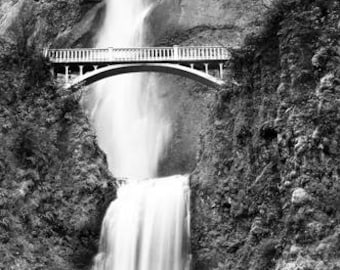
[{"left": 0, "top": 0, "right": 104, "bottom": 48}]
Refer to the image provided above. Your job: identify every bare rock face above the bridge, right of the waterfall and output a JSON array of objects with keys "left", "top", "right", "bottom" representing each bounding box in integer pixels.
[{"left": 149, "top": 0, "right": 272, "bottom": 46}]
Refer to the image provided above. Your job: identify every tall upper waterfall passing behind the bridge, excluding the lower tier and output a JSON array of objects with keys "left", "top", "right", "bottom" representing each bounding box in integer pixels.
[{"left": 92, "top": 0, "right": 170, "bottom": 178}]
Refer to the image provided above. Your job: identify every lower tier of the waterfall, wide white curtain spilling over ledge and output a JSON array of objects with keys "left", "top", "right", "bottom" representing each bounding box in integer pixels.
[{"left": 94, "top": 176, "right": 190, "bottom": 270}]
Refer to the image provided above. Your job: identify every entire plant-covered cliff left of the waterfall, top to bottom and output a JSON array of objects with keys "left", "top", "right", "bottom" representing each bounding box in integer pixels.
[{"left": 0, "top": 1, "right": 115, "bottom": 270}]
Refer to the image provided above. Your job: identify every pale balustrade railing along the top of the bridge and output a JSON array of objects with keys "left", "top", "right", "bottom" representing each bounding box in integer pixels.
[{"left": 44, "top": 46, "right": 231, "bottom": 63}]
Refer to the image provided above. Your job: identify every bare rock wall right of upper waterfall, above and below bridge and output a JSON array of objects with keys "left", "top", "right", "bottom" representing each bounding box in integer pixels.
[{"left": 153, "top": 0, "right": 271, "bottom": 175}]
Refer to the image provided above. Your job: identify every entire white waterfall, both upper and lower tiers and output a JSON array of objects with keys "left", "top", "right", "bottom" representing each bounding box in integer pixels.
[{"left": 92, "top": 0, "right": 190, "bottom": 270}]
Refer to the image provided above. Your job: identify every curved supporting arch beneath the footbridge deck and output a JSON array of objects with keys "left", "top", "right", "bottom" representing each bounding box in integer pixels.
[{"left": 67, "top": 63, "right": 225, "bottom": 88}]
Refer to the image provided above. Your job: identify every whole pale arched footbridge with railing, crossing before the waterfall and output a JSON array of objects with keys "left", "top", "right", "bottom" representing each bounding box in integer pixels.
[{"left": 44, "top": 46, "right": 231, "bottom": 88}]
